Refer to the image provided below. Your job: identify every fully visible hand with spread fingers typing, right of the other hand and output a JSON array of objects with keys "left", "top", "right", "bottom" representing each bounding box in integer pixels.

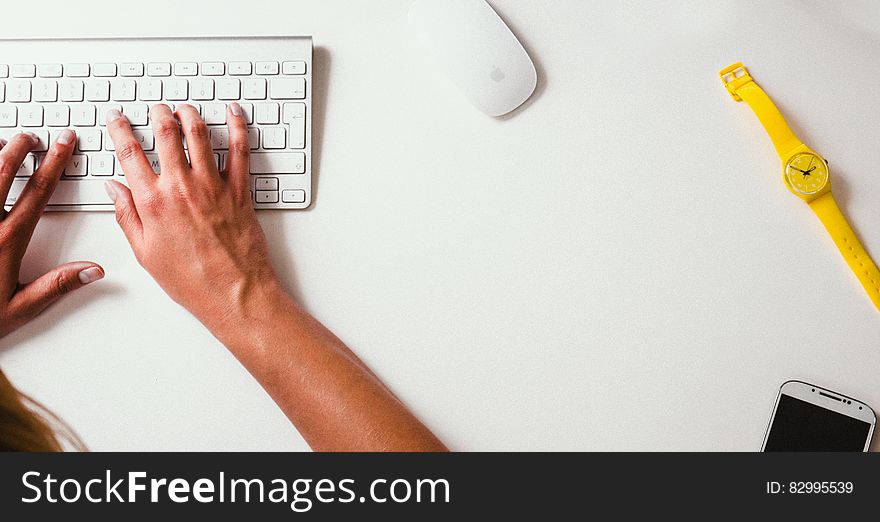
[{"left": 106, "top": 103, "right": 277, "bottom": 334}]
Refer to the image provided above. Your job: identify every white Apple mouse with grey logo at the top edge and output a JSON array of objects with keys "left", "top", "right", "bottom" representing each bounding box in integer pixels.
[{"left": 409, "top": 0, "right": 538, "bottom": 116}]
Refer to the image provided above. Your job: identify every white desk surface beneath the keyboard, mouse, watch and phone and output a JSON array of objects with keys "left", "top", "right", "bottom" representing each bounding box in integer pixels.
[{"left": 0, "top": 0, "right": 880, "bottom": 451}]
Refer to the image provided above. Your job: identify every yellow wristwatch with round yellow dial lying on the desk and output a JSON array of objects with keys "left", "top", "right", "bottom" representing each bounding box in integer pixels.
[{"left": 720, "top": 63, "right": 880, "bottom": 309}]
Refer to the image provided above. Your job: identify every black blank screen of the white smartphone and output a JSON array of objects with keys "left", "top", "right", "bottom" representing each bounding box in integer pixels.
[{"left": 764, "top": 394, "right": 871, "bottom": 451}]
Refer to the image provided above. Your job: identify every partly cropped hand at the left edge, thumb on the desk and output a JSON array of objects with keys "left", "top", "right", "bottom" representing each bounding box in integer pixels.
[{"left": 0, "top": 130, "right": 104, "bottom": 337}]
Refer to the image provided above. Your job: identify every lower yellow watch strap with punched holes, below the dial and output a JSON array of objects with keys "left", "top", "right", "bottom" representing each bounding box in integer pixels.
[{"left": 810, "top": 192, "right": 880, "bottom": 309}]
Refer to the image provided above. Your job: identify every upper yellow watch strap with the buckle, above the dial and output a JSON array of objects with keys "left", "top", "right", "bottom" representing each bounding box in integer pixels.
[{"left": 719, "top": 63, "right": 801, "bottom": 156}]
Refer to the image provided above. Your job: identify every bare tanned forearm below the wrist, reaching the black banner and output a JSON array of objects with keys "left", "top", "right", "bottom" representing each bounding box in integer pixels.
[{"left": 206, "top": 285, "right": 446, "bottom": 451}]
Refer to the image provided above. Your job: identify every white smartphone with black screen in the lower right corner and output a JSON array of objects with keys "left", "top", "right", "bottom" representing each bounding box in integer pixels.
[{"left": 761, "top": 381, "right": 877, "bottom": 451}]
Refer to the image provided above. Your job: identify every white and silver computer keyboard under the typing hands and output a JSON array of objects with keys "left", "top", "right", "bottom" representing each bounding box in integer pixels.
[{"left": 0, "top": 37, "right": 312, "bottom": 210}]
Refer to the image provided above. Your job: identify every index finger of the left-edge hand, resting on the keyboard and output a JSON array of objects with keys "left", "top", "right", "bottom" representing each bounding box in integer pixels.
[{"left": 6, "top": 129, "right": 76, "bottom": 230}]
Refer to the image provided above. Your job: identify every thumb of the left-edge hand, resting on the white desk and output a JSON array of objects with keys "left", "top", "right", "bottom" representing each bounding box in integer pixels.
[{"left": 9, "top": 261, "right": 104, "bottom": 319}]
